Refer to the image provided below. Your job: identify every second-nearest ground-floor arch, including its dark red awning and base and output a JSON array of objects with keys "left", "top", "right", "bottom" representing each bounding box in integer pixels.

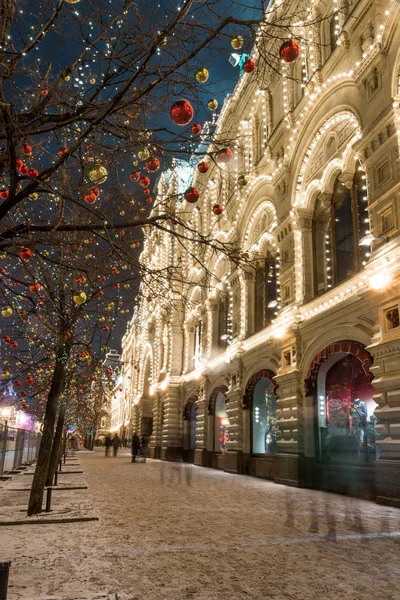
[{"left": 243, "top": 369, "right": 279, "bottom": 479}]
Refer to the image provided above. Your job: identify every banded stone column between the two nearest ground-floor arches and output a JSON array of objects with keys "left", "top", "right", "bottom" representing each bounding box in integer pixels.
[{"left": 275, "top": 370, "right": 304, "bottom": 486}]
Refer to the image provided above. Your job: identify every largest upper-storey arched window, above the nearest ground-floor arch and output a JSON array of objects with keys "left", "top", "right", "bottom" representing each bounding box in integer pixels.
[{"left": 313, "top": 171, "right": 369, "bottom": 296}]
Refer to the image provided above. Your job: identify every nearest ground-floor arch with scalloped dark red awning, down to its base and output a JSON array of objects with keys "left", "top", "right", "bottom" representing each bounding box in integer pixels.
[{"left": 305, "top": 341, "right": 378, "bottom": 495}]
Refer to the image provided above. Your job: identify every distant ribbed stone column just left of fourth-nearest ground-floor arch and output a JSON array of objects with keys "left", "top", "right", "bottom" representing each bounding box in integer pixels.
[{"left": 161, "top": 383, "right": 183, "bottom": 461}]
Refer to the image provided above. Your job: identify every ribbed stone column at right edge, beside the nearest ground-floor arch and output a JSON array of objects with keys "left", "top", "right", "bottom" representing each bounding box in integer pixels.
[{"left": 367, "top": 339, "right": 400, "bottom": 507}]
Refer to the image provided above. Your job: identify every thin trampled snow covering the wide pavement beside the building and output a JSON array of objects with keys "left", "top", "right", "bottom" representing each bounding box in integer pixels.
[{"left": 0, "top": 451, "right": 400, "bottom": 600}]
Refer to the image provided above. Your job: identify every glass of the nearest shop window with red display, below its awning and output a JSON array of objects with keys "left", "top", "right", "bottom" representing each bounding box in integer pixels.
[{"left": 317, "top": 352, "right": 378, "bottom": 463}]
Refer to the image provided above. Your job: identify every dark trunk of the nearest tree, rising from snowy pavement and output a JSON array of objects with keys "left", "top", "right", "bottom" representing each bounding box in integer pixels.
[{"left": 28, "top": 348, "right": 65, "bottom": 516}]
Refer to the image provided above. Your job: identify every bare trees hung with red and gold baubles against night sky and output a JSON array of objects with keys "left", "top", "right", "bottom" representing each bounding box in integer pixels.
[{"left": 0, "top": 0, "right": 334, "bottom": 515}]
